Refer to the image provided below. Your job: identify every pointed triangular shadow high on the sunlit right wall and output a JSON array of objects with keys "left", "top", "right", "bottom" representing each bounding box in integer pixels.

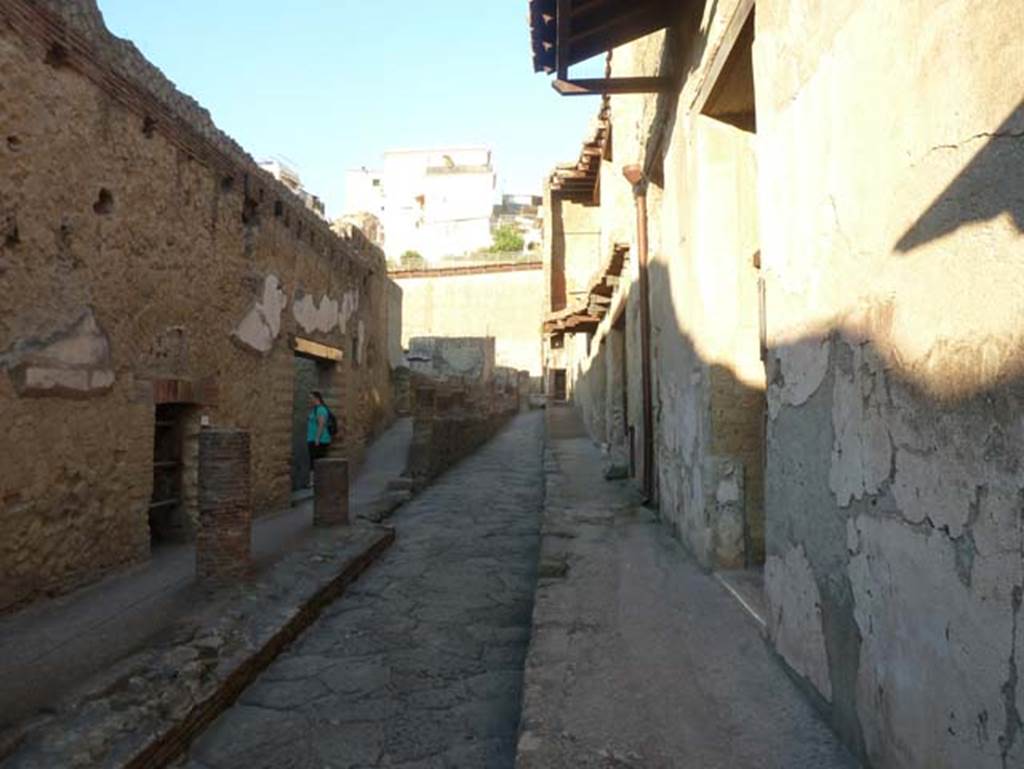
[{"left": 896, "top": 101, "right": 1024, "bottom": 253}]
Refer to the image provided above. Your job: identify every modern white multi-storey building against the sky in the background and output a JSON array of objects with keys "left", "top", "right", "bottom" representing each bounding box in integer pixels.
[{"left": 345, "top": 147, "right": 496, "bottom": 263}]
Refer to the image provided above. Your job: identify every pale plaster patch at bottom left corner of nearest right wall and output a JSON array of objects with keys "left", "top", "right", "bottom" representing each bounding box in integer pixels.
[{"left": 765, "top": 545, "right": 833, "bottom": 702}]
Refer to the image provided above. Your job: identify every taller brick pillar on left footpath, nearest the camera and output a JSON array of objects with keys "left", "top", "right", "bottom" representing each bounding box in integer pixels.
[{"left": 196, "top": 429, "right": 253, "bottom": 581}]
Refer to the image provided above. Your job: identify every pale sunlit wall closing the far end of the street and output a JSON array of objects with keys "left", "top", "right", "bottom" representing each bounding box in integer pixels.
[{"left": 392, "top": 263, "right": 544, "bottom": 377}]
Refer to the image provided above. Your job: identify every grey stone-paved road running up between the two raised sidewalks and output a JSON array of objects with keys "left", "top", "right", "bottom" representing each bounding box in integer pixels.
[{"left": 186, "top": 413, "right": 544, "bottom": 769}]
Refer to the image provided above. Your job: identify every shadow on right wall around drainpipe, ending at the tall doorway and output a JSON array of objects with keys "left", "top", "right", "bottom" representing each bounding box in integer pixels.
[{"left": 573, "top": 261, "right": 765, "bottom": 568}]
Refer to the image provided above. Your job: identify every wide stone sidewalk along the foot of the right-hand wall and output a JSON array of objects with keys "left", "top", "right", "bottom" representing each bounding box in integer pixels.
[{"left": 516, "top": 408, "right": 857, "bottom": 769}]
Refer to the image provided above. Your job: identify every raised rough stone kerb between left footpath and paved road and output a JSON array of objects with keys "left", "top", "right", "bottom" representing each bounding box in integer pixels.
[{"left": 0, "top": 524, "right": 395, "bottom": 769}]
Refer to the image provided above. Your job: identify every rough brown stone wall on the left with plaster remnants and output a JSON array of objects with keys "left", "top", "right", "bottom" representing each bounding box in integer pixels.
[{"left": 0, "top": 0, "right": 390, "bottom": 609}]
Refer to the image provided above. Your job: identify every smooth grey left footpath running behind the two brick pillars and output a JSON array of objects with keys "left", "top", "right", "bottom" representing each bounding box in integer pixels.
[{"left": 0, "top": 418, "right": 413, "bottom": 733}]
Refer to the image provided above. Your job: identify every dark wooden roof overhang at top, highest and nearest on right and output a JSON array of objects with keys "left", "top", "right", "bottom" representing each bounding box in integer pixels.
[{"left": 529, "top": 0, "right": 684, "bottom": 95}]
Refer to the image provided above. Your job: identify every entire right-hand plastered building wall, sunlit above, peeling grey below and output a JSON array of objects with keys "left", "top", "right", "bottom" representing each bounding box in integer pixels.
[{"left": 551, "top": 0, "right": 1024, "bottom": 769}]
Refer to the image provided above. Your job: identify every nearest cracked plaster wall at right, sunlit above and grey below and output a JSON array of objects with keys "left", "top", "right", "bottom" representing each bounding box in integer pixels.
[{"left": 755, "top": 0, "right": 1024, "bottom": 768}]
